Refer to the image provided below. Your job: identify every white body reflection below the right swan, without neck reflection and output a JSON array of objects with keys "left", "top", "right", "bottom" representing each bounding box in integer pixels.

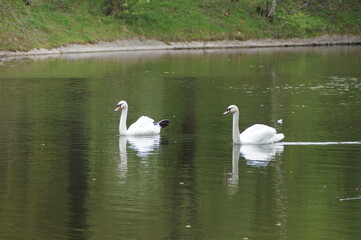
[{"left": 240, "top": 144, "right": 284, "bottom": 167}]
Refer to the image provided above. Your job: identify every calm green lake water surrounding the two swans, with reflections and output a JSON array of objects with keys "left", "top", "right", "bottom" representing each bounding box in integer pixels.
[{"left": 0, "top": 46, "right": 361, "bottom": 240}]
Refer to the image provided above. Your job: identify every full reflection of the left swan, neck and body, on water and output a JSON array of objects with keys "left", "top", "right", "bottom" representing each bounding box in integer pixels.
[{"left": 118, "top": 135, "right": 160, "bottom": 176}]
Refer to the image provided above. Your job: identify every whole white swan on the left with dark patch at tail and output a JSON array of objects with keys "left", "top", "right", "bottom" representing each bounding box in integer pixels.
[{"left": 114, "top": 101, "right": 169, "bottom": 136}]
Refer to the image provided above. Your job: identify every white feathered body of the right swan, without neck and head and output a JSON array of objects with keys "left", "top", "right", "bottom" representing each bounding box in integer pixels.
[{"left": 239, "top": 124, "right": 284, "bottom": 144}]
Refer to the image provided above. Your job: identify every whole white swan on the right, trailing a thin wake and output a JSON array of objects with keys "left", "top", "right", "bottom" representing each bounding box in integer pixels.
[{"left": 223, "top": 105, "right": 285, "bottom": 144}]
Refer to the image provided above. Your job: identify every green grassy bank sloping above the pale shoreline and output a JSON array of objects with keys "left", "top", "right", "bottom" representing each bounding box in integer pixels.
[{"left": 0, "top": 0, "right": 361, "bottom": 51}]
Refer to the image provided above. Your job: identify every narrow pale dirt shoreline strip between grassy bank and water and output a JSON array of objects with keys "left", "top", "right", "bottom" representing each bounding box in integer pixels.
[{"left": 0, "top": 35, "right": 361, "bottom": 58}]
